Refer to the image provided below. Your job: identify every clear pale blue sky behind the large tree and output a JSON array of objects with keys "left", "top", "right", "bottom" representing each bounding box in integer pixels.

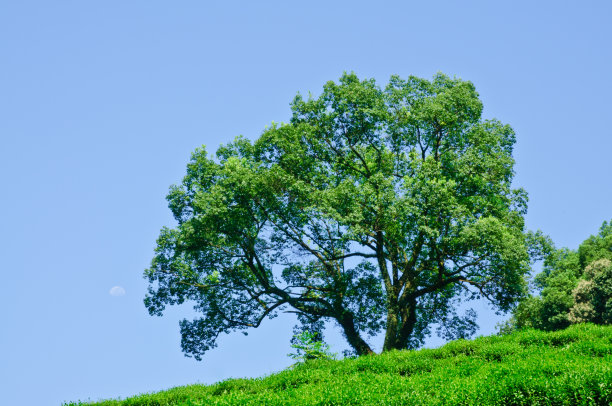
[{"left": 0, "top": 0, "right": 612, "bottom": 406}]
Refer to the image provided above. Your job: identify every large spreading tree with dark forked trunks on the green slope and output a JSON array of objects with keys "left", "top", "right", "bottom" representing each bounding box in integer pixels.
[{"left": 145, "top": 74, "right": 541, "bottom": 359}]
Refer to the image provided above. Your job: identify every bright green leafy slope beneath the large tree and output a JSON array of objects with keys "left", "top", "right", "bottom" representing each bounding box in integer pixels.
[{"left": 65, "top": 325, "right": 612, "bottom": 406}]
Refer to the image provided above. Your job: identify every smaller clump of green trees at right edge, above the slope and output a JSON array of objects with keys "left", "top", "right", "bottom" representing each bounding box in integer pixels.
[{"left": 505, "top": 221, "right": 612, "bottom": 331}]
